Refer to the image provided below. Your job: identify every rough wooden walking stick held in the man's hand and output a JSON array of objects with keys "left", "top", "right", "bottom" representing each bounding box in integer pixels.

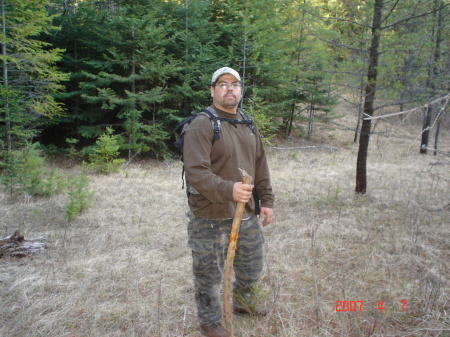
[{"left": 224, "top": 169, "right": 252, "bottom": 337}]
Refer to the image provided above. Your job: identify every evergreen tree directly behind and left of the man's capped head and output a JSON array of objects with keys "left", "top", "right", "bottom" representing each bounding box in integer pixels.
[{"left": 162, "top": 0, "right": 230, "bottom": 115}]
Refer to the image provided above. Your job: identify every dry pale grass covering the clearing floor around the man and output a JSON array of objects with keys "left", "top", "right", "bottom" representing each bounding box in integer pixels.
[{"left": 0, "top": 109, "right": 450, "bottom": 337}]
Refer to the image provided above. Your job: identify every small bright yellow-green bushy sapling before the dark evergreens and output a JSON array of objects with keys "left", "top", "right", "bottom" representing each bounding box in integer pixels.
[{"left": 89, "top": 127, "right": 125, "bottom": 174}]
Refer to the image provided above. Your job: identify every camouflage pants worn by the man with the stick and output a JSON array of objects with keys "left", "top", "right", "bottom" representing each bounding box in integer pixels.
[{"left": 188, "top": 214, "right": 264, "bottom": 325}]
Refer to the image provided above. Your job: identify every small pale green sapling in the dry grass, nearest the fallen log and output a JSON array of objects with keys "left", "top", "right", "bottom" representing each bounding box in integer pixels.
[{"left": 64, "top": 174, "right": 94, "bottom": 222}]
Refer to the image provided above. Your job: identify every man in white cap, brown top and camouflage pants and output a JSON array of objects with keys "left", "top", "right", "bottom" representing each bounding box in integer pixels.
[{"left": 183, "top": 67, "right": 274, "bottom": 337}]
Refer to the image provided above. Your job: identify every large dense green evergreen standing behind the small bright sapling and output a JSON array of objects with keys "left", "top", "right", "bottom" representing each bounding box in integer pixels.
[{"left": 70, "top": 1, "right": 176, "bottom": 159}]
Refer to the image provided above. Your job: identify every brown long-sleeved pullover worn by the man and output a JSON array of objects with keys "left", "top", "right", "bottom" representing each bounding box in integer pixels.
[{"left": 183, "top": 106, "right": 274, "bottom": 219}]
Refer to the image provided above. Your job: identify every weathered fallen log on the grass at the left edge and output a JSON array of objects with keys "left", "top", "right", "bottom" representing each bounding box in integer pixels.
[{"left": 0, "top": 230, "right": 47, "bottom": 258}]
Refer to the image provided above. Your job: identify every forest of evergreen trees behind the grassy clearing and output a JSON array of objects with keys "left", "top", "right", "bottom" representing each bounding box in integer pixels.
[{"left": 0, "top": 0, "right": 450, "bottom": 168}]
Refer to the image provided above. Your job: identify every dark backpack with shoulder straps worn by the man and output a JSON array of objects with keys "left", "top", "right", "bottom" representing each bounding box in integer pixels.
[{"left": 173, "top": 107, "right": 259, "bottom": 214}]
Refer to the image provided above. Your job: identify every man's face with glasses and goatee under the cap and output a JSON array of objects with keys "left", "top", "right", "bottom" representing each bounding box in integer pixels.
[{"left": 211, "top": 74, "right": 242, "bottom": 113}]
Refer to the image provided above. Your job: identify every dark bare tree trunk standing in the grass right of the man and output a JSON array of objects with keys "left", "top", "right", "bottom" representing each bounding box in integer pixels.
[{"left": 355, "top": 0, "right": 384, "bottom": 194}]
